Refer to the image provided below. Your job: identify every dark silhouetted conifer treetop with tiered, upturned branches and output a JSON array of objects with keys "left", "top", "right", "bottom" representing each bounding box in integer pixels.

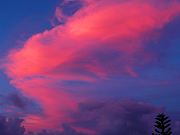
[{"left": 152, "top": 113, "right": 172, "bottom": 135}]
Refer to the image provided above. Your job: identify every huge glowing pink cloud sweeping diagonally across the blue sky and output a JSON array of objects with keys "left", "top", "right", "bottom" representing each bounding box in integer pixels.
[{"left": 3, "top": 0, "right": 180, "bottom": 132}]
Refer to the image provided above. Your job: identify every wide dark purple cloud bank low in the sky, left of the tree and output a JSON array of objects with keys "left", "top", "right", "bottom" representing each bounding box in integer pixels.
[{"left": 72, "top": 101, "right": 165, "bottom": 135}]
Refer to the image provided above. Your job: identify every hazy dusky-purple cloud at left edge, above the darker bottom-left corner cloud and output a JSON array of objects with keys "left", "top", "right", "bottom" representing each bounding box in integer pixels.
[{"left": 0, "top": 93, "right": 42, "bottom": 117}]
